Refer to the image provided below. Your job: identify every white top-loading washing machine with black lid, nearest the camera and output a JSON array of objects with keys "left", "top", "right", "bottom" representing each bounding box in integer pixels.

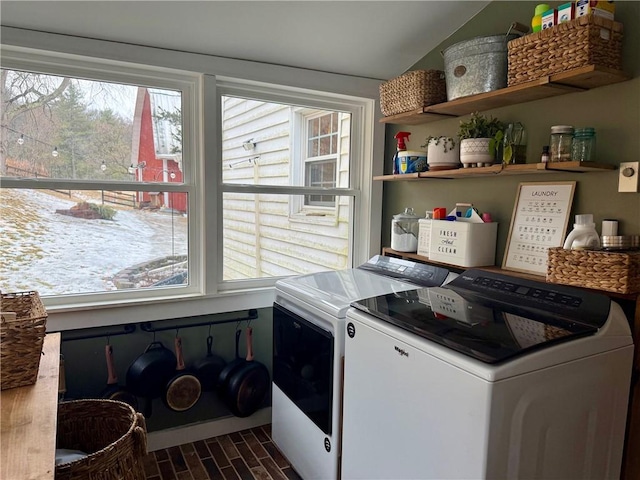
[{"left": 342, "top": 270, "right": 633, "bottom": 480}]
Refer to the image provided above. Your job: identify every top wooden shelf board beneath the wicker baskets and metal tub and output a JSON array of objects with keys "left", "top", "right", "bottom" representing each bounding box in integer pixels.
[{"left": 380, "top": 65, "right": 631, "bottom": 125}]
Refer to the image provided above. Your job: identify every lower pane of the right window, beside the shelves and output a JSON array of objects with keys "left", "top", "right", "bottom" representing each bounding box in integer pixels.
[{"left": 222, "top": 193, "right": 352, "bottom": 280}]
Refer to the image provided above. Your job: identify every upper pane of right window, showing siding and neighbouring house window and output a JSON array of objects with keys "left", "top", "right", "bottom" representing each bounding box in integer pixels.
[{"left": 221, "top": 96, "right": 351, "bottom": 188}]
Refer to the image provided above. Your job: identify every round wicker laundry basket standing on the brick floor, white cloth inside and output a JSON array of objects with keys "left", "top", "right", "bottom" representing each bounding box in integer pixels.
[{"left": 55, "top": 400, "right": 147, "bottom": 480}]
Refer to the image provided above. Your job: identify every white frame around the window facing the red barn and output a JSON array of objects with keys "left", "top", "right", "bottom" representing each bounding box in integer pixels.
[{"left": 0, "top": 51, "right": 204, "bottom": 309}]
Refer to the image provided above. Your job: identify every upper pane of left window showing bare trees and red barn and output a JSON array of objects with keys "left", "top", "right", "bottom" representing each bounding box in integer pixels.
[{"left": 0, "top": 70, "right": 182, "bottom": 182}]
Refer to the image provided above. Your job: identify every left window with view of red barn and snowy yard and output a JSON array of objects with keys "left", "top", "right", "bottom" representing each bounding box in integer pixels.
[{"left": 0, "top": 55, "right": 198, "bottom": 303}]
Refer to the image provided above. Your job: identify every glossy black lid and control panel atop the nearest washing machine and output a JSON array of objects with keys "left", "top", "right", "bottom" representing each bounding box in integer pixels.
[{"left": 352, "top": 270, "right": 611, "bottom": 364}]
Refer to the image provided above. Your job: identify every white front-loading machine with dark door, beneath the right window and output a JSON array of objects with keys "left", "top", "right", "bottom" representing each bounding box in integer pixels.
[{"left": 271, "top": 256, "right": 456, "bottom": 480}]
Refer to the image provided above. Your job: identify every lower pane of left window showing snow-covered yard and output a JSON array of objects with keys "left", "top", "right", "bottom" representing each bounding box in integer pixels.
[{"left": 0, "top": 188, "right": 188, "bottom": 296}]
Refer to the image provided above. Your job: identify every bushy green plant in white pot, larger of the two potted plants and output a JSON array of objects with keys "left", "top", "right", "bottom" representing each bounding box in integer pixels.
[{"left": 458, "top": 112, "right": 504, "bottom": 168}]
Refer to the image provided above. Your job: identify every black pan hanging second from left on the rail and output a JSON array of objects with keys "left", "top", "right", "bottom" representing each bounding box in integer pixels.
[{"left": 127, "top": 342, "right": 177, "bottom": 417}]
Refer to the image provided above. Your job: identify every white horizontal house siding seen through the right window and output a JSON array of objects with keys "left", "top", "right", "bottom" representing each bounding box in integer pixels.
[{"left": 222, "top": 97, "right": 350, "bottom": 280}]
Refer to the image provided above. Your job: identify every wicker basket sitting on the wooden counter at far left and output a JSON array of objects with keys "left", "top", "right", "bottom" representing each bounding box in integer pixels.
[{"left": 0, "top": 292, "right": 47, "bottom": 390}]
